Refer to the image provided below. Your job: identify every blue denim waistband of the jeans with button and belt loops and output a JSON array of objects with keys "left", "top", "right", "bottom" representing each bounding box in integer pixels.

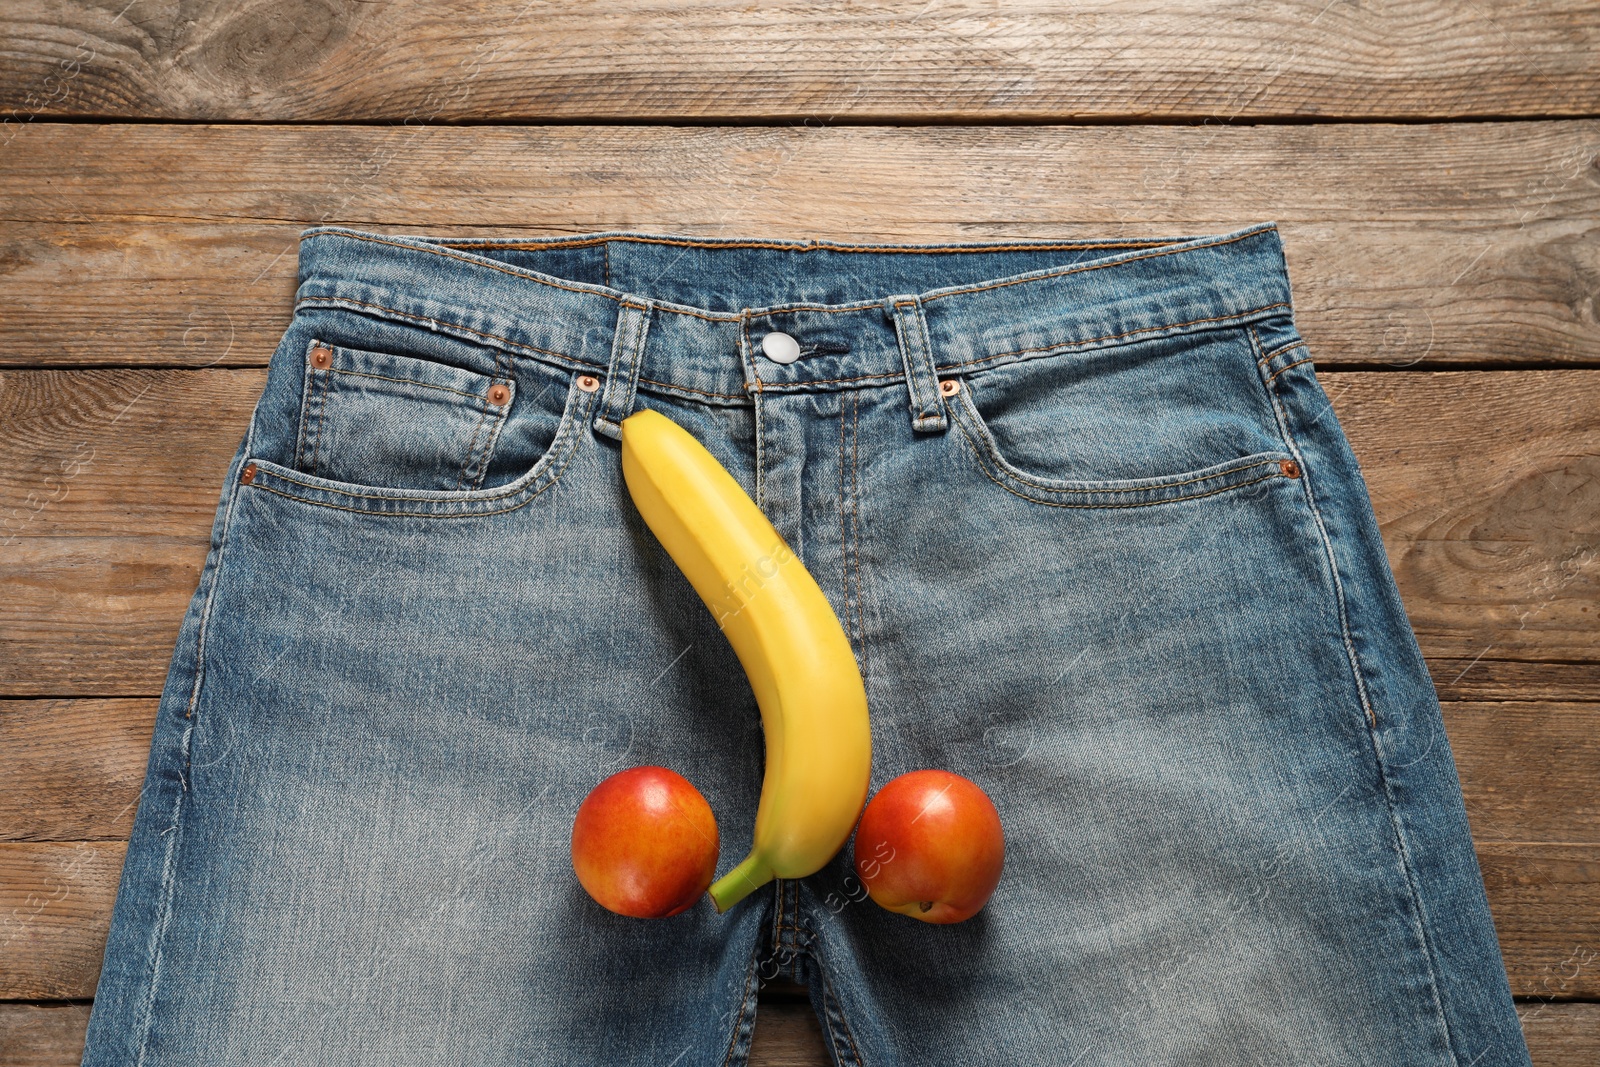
[{"left": 298, "top": 222, "right": 1290, "bottom": 429}]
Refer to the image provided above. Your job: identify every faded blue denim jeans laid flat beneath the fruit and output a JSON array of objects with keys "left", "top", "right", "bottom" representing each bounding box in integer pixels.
[{"left": 83, "top": 226, "right": 1528, "bottom": 1067}]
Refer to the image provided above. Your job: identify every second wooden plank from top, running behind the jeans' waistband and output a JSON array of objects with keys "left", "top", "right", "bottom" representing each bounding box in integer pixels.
[{"left": 0, "top": 122, "right": 1600, "bottom": 366}]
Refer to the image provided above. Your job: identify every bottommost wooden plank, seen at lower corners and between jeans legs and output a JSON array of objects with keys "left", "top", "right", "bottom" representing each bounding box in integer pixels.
[{"left": 0, "top": 997, "right": 1600, "bottom": 1067}]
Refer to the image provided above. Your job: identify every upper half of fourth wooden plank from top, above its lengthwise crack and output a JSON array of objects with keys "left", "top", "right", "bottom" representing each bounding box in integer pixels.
[{"left": 0, "top": 697, "right": 1600, "bottom": 845}]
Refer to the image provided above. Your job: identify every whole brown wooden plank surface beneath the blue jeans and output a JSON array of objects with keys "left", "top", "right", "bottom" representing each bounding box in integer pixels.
[{"left": 0, "top": 0, "right": 1600, "bottom": 1065}]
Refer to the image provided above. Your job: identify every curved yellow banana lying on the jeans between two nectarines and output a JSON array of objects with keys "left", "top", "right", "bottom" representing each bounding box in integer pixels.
[{"left": 622, "top": 408, "right": 872, "bottom": 912}]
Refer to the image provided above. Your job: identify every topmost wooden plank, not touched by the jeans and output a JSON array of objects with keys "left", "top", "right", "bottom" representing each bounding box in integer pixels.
[{"left": 0, "top": 0, "right": 1600, "bottom": 123}]
